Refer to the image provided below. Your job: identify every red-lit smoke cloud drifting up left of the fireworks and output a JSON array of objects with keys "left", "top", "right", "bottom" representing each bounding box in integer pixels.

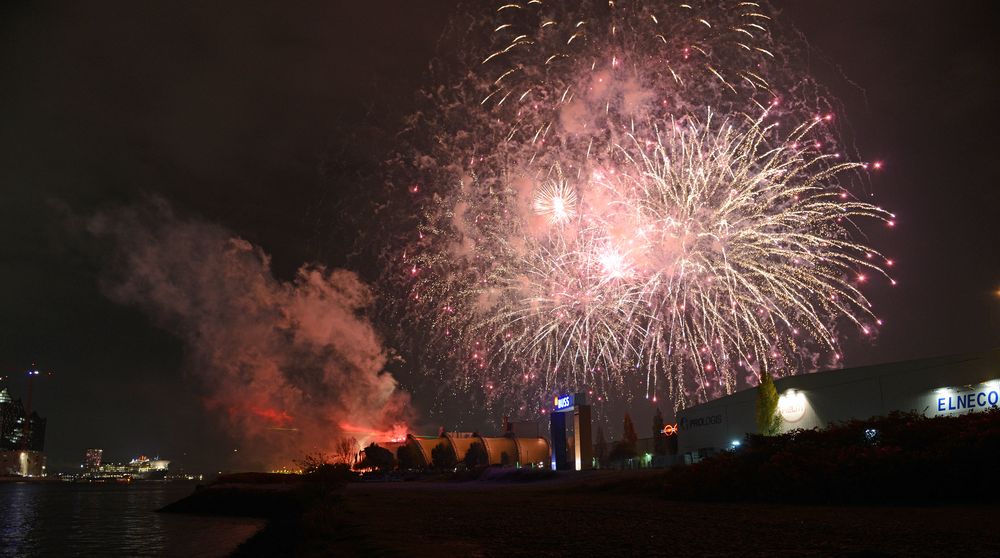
[{"left": 87, "top": 201, "right": 409, "bottom": 465}]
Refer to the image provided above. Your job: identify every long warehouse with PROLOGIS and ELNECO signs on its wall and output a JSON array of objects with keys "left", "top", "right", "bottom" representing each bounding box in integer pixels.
[{"left": 677, "top": 349, "right": 1000, "bottom": 463}]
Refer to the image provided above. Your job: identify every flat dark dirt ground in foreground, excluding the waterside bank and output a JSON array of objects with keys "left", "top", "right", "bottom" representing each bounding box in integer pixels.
[{"left": 314, "top": 473, "right": 1000, "bottom": 557}]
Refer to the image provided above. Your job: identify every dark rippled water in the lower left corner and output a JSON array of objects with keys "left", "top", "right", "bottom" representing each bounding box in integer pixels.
[{"left": 0, "top": 483, "right": 263, "bottom": 558}]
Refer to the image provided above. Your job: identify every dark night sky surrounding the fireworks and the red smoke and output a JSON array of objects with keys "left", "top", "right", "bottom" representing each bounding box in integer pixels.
[{"left": 0, "top": 0, "right": 1000, "bottom": 470}]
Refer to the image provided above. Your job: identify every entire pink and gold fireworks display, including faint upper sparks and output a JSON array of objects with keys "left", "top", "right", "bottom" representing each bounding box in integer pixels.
[{"left": 392, "top": 0, "right": 893, "bottom": 410}]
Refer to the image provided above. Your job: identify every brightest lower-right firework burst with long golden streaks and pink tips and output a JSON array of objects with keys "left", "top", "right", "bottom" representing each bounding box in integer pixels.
[{"left": 450, "top": 114, "right": 892, "bottom": 412}]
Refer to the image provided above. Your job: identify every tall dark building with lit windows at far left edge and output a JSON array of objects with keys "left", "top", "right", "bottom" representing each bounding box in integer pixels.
[{"left": 0, "top": 388, "right": 45, "bottom": 477}]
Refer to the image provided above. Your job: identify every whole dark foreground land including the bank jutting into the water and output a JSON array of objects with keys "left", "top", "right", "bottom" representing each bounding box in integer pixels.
[{"left": 163, "top": 471, "right": 1000, "bottom": 558}]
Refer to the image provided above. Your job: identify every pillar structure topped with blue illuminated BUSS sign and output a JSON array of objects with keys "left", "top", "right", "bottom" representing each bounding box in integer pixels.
[{"left": 549, "top": 393, "right": 594, "bottom": 471}]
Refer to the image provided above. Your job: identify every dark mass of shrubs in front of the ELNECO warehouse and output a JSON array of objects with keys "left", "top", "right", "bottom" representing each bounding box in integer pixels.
[{"left": 643, "top": 410, "right": 1000, "bottom": 503}]
